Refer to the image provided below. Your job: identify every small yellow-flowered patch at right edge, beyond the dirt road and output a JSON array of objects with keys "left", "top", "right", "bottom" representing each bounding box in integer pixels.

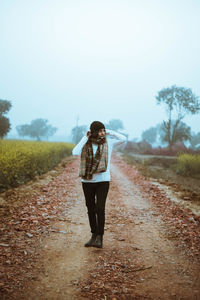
[{"left": 177, "top": 154, "right": 200, "bottom": 176}]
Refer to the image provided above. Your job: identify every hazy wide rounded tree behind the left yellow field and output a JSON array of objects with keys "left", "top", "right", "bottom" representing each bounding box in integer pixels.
[{"left": 16, "top": 119, "right": 57, "bottom": 141}]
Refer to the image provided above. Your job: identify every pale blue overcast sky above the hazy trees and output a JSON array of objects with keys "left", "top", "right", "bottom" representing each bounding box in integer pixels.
[{"left": 0, "top": 0, "right": 200, "bottom": 138}]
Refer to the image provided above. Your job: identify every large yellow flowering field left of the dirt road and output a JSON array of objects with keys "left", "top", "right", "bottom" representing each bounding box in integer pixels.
[{"left": 0, "top": 140, "right": 74, "bottom": 188}]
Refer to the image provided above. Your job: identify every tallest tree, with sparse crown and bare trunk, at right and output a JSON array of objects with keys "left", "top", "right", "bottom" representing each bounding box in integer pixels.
[{"left": 156, "top": 85, "right": 200, "bottom": 150}]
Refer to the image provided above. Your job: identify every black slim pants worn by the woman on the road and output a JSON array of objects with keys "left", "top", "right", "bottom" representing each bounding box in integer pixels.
[{"left": 82, "top": 181, "right": 110, "bottom": 235}]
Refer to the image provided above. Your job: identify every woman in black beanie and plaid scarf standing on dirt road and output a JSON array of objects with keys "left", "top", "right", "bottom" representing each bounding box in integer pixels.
[{"left": 72, "top": 121, "right": 126, "bottom": 248}]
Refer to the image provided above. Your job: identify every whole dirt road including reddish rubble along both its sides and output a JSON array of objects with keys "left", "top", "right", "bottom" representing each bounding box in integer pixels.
[{"left": 0, "top": 156, "right": 200, "bottom": 300}]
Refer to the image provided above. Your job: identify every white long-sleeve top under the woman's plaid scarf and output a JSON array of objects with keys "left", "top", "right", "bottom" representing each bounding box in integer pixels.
[{"left": 72, "top": 129, "right": 126, "bottom": 183}]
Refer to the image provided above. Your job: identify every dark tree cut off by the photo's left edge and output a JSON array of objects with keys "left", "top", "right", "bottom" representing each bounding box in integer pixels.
[{"left": 0, "top": 100, "right": 12, "bottom": 138}]
